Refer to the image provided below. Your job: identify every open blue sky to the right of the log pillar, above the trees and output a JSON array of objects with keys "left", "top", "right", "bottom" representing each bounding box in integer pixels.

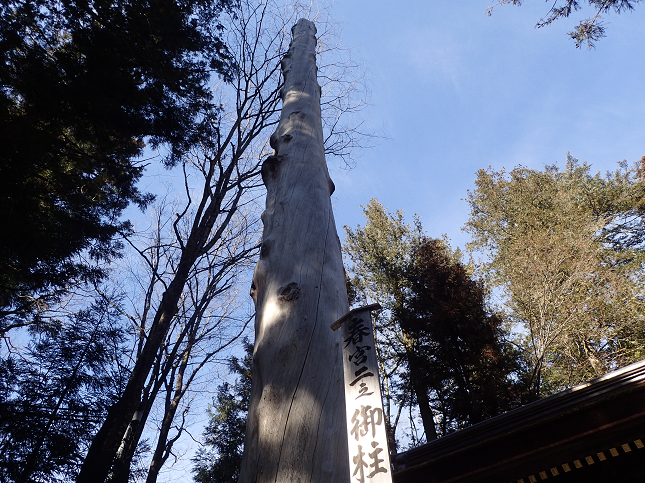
[{"left": 330, "top": 0, "right": 645, "bottom": 253}]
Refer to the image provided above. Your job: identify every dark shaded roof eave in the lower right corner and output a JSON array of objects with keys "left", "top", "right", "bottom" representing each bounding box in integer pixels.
[{"left": 394, "top": 361, "right": 645, "bottom": 483}]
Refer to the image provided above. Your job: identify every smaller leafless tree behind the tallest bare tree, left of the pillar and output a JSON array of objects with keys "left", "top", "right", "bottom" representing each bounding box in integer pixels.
[{"left": 102, "top": 195, "right": 256, "bottom": 482}]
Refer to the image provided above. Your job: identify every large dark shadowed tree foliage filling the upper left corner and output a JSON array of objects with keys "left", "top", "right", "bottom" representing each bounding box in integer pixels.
[{"left": 0, "top": 0, "right": 234, "bottom": 331}]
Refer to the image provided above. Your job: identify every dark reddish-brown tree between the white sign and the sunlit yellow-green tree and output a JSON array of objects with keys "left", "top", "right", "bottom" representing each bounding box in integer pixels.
[{"left": 394, "top": 239, "right": 522, "bottom": 434}]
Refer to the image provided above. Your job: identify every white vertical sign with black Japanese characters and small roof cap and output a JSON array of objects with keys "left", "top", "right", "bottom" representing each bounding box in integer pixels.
[{"left": 331, "top": 304, "right": 392, "bottom": 483}]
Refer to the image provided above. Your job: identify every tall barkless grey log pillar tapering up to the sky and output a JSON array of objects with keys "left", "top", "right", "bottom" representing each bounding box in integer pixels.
[{"left": 239, "top": 20, "right": 349, "bottom": 483}]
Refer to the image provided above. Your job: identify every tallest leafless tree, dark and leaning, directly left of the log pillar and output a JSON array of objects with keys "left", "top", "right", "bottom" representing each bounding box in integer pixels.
[{"left": 77, "top": 0, "right": 364, "bottom": 483}]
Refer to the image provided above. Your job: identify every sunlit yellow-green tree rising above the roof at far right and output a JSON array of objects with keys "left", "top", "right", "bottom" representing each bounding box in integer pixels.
[{"left": 465, "top": 155, "right": 645, "bottom": 397}]
